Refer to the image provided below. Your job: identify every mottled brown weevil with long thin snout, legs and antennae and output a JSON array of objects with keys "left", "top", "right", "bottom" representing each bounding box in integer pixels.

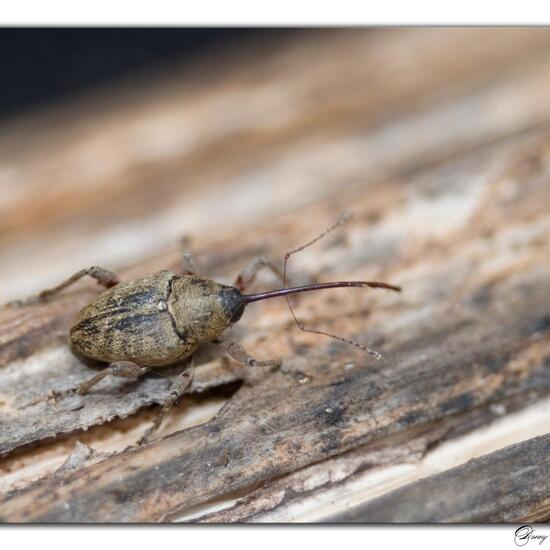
[{"left": 8, "top": 219, "right": 401, "bottom": 443}]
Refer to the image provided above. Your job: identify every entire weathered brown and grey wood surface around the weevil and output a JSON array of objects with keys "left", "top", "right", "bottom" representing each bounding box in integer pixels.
[{"left": 0, "top": 28, "right": 550, "bottom": 522}]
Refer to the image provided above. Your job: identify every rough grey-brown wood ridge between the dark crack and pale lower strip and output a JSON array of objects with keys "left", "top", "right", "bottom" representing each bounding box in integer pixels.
[{"left": 0, "top": 268, "right": 550, "bottom": 521}]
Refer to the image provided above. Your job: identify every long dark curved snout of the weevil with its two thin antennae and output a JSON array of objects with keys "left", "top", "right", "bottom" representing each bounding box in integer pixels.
[{"left": 243, "top": 214, "right": 401, "bottom": 359}]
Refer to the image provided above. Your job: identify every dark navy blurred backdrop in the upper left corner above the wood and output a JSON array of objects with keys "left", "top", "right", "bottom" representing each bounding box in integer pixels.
[{"left": 0, "top": 28, "right": 276, "bottom": 117}]
